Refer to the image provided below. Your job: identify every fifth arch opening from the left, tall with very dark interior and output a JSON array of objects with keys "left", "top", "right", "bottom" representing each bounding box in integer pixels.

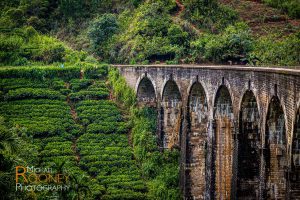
[{"left": 237, "top": 90, "right": 261, "bottom": 199}]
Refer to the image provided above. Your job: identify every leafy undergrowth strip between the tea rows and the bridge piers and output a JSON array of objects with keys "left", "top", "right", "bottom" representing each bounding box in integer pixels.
[{"left": 109, "top": 69, "right": 181, "bottom": 200}]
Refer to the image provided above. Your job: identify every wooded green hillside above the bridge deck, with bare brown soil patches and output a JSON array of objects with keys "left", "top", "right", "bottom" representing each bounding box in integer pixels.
[{"left": 0, "top": 0, "right": 300, "bottom": 66}]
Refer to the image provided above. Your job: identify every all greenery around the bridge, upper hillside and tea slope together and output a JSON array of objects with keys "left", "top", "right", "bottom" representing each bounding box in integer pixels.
[{"left": 0, "top": 0, "right": 300, "bottom": 200}]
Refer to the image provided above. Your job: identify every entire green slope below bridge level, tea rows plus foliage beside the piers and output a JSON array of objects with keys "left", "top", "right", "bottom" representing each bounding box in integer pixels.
[{"left": 0, "top": 65, "right": 180, "bottom": 199}]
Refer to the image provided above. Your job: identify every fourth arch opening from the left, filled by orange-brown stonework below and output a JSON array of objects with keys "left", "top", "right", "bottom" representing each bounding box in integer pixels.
[{"left": 213, "top": 85, "right": 234, "bottom": 199}]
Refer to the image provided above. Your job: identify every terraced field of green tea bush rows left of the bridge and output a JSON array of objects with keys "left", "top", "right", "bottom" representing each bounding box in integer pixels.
[{"left": 0, "top": 66, "right": 148, "bottom": 199}]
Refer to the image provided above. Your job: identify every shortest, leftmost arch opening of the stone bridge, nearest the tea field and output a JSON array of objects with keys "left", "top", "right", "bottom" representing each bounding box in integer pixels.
[{"left": 137, "top": 77, "right": 156, "bottom": 106}]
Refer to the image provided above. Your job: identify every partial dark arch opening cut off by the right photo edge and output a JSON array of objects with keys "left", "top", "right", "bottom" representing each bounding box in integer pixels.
[{"left": 290, "top": 107, "right": 300, "bottom": 199}]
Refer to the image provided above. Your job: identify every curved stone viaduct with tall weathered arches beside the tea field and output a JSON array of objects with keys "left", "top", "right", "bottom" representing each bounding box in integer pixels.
[{"left": 115, "top": 65, "right": 300, "bottom": 199}]
